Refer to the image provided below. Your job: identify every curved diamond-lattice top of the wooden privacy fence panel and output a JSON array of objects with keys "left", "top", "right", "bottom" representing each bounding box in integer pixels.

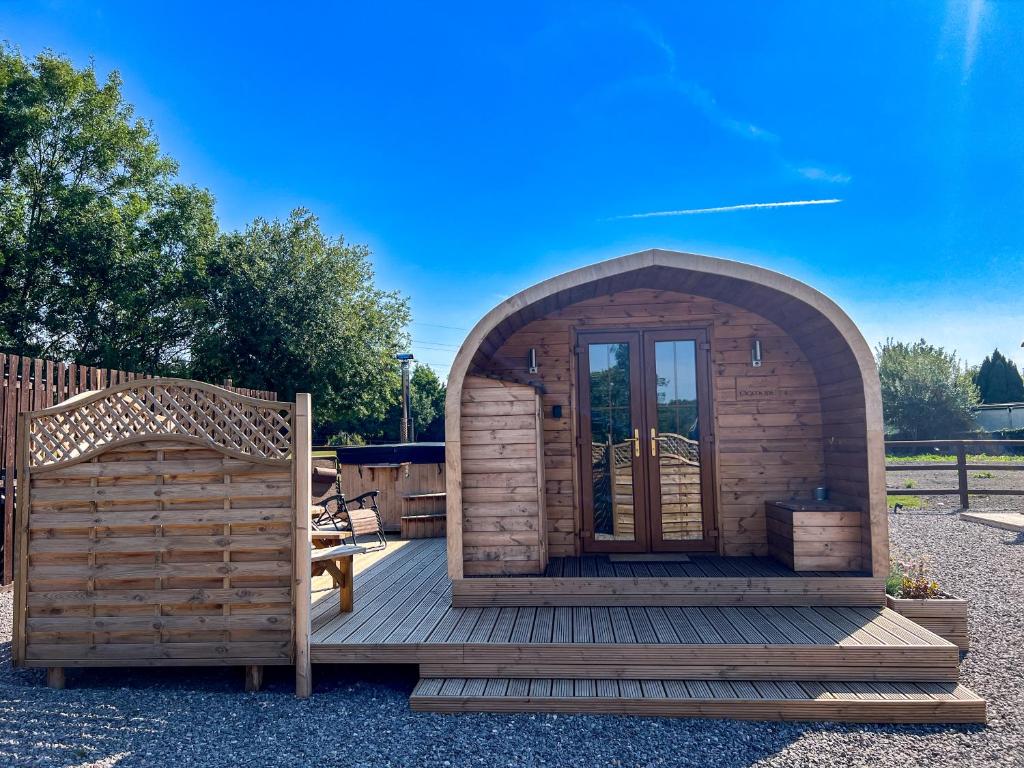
[{"left": 27, "top": 379, "right": 294, "bottom": 468}]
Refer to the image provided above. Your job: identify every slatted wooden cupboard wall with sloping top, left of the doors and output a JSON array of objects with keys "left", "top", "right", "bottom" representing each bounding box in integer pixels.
[{"left": 461, "top": 376, "right": 548, "bottom": 575}]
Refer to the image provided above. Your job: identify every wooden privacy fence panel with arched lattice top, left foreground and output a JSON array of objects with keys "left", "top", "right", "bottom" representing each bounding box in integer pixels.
[{"left": 13, "top": 379, "right": 309, "bottom": 696}]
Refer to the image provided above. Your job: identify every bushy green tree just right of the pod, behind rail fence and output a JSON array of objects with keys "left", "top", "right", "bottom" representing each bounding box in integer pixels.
[{"left": 876, "top": 339, "right": 978, "bottom": 439}]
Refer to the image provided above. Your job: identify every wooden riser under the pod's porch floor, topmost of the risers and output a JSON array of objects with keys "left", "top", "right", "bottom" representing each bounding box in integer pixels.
[{"left": 452, "top": 577, "right": 885, "bottom": 608}]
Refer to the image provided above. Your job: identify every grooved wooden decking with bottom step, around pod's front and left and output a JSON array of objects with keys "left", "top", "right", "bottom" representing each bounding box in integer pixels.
[{"left": 310, "top": 539, "right": 984, "bottom": 722}]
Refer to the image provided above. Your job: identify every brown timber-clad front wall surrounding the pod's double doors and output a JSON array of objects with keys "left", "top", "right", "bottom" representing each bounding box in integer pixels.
[{"left": 477, "top": 289, "right": 825, "bottom": 556}]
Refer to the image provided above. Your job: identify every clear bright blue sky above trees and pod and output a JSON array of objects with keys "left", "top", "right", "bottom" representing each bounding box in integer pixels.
[{"left": 0, "top": 0, "right": 1024, "bottom": 373}]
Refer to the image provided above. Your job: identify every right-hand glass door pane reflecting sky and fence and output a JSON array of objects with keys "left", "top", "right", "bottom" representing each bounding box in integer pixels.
[{"left": 654, "top": 340, "right": 703, "bottom": 542}]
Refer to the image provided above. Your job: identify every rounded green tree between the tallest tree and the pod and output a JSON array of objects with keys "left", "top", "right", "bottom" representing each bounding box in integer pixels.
[{"left": 193, "top": 209, "right": 410, "bottom": 434}]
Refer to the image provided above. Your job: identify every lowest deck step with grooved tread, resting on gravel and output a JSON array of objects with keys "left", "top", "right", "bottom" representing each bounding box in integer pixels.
[{"left": 410, "top": 677, "right": 985, "bottom": 723}]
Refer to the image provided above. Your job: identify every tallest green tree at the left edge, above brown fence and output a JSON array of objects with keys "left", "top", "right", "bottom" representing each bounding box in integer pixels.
[{"left": 0, "top": 47, "right": 217, "bottom": 373}]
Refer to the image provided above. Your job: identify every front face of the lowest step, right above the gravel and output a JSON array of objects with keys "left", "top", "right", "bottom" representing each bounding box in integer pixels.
[{"left": 410, "top": 695, "right": 985, "bottom": 723}]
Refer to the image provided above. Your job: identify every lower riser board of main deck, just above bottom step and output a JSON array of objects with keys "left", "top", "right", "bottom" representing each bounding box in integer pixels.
[{"left": 420, "top": 664, "right": 959, "bottom": 683}]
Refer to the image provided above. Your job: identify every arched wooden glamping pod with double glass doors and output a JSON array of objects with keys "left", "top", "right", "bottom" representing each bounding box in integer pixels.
[{"left": 446, "top": 251, "right": 888, "bottom": 589}]
